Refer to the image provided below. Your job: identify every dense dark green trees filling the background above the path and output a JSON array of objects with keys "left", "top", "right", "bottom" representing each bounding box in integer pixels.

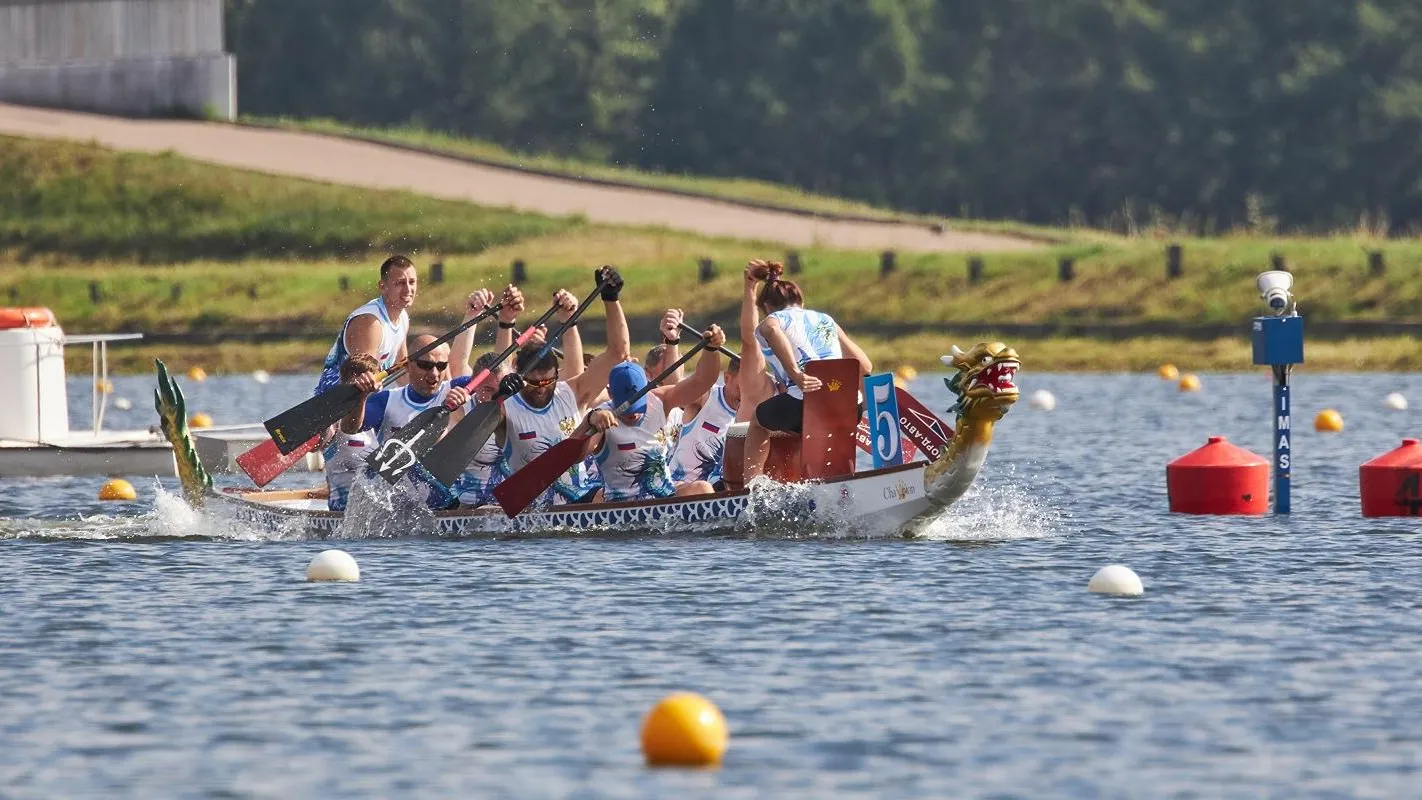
[{"left": 228, "top": 0, "right": 1422, "bottom": 233}]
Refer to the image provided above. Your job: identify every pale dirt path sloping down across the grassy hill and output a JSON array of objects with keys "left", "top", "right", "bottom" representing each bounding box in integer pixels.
[{"left": 0, "top": 104, "right": 1042, "bottom": 252}]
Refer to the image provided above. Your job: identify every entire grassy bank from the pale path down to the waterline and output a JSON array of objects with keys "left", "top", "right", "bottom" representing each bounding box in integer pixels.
[{"left": 0, "top": 138, "right": 1422, "bottom": 371}]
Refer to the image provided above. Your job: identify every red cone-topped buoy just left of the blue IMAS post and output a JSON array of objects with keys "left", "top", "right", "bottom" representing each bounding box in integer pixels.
[{"left": 1165, "top": 436, "right": 1268, "bottom": 514}]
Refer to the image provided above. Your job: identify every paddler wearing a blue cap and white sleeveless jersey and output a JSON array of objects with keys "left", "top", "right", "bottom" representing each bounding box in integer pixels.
[{"left": 587, "top": 325, "right": 725, "bottom": 503}]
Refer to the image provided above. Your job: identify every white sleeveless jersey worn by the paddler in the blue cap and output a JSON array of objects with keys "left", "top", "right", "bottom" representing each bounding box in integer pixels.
[{"left": 597, "top": 395, "right": 677, "bottom": 503}]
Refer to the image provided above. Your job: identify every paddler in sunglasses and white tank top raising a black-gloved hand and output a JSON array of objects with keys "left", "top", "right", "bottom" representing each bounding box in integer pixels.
[{"left": 496, "top": 267, "right": 631, "bottom": 507}]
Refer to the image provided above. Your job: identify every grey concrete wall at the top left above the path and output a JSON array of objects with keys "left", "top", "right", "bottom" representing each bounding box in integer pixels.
[{"left": 0, "top": 0, "right": 237, "bottom": 119}]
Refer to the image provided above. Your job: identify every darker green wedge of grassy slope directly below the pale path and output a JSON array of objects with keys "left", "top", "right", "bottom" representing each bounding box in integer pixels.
[{"left": 0, "top": 136, "right": 579, "bottom": 261}]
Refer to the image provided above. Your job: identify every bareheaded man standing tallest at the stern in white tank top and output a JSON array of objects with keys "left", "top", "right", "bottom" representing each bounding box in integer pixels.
[{"left": 314, "top": 256, "right": 418, "bottom": 395}]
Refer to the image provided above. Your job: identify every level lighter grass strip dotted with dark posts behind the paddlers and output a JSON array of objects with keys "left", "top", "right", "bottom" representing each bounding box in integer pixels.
[{"left": 19, "top": 226, "right": 1422, "bottom": 333}]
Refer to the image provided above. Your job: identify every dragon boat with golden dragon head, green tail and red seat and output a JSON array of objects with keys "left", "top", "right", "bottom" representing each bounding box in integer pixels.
[{"left": 154, "top": 342, "right": 1021, "bottom": 537}]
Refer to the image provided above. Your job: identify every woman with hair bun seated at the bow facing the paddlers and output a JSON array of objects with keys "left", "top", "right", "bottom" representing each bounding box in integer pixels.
[{"left": 745, "top": 261, "right": 875, "bottom": 482}]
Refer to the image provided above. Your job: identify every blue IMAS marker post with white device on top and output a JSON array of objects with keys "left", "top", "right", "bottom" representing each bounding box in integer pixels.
[{"left": 1250, "top": 270, "right": 1304, "bottom": 514}]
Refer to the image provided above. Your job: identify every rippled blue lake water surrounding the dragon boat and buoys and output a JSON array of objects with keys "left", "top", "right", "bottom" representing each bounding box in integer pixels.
[{"left": 0, "top": 369, "right": 1422, "bottom": 797}]
